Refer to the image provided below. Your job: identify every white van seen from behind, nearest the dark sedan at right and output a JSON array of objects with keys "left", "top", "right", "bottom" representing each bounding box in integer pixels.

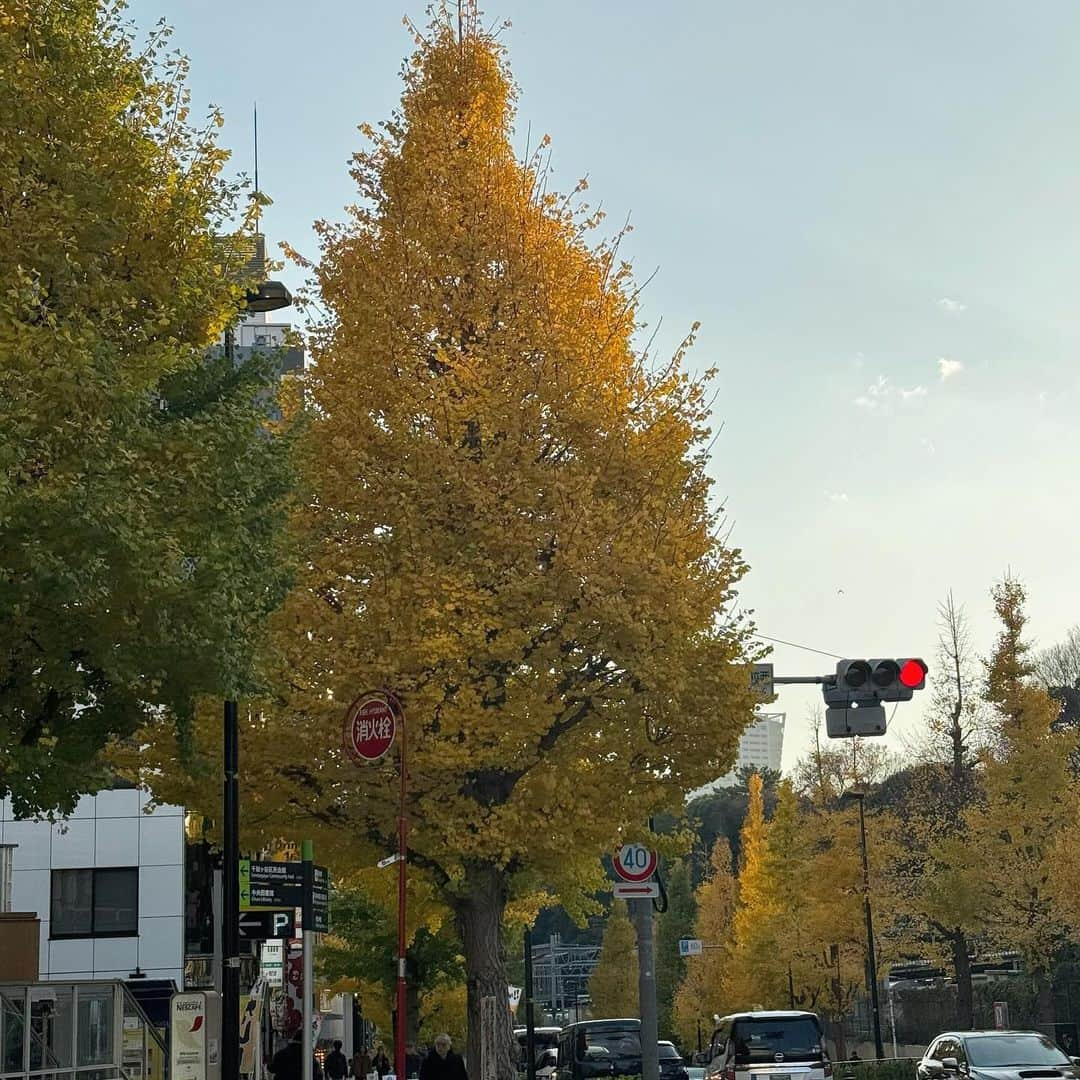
[{"left": 704, "top": 1012, "right": 833, "bottom": 1080}]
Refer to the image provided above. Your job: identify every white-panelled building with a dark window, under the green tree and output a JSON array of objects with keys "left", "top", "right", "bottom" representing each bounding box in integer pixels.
[{"left": 0, "top": 788, "right": 185, "bottom": 988}]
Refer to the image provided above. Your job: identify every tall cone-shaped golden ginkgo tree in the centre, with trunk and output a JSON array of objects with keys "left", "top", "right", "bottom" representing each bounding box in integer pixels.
[{"left": 128, "top": 4, "right": 752, "bottom": 1080}]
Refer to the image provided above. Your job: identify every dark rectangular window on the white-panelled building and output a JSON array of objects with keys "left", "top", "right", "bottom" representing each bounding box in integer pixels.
[{"left": 49, "top": 866, "right": 138, "bottom": 937}]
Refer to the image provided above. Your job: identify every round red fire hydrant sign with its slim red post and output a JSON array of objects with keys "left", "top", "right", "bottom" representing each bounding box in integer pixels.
[{"left": 343, "top": 690, "right": 408, "bottom": 1080}]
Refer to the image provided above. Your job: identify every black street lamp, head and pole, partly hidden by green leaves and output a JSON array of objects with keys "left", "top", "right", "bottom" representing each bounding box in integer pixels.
[{"left": 221, "top": 272, "right": 291, "bottom": 1080}]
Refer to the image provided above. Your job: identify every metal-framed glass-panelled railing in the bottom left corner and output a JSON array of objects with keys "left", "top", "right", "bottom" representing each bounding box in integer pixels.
[{"left": 0, "top": 981, "right": 168, "bottom": 1080}]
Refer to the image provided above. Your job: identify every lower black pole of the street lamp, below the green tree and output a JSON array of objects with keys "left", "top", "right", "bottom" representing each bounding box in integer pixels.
[{"left": 221, "top": 701, "right": 237, "bottom": 1080}]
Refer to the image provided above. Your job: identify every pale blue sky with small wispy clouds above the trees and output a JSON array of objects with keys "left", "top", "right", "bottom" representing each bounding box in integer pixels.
[{"left": 130, "top": 0, "right": 1080, "bottom": 768}]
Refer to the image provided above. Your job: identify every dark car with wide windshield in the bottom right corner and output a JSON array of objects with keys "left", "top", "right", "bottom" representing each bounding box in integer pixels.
[{"left": 916, "top": 1031, "right": 1080, "bottom": 1080}]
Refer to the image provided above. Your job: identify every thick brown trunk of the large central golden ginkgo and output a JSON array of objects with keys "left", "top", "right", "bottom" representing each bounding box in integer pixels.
[{"left": 454, "top": 863, "right": 517, "bottom": 1080}]
